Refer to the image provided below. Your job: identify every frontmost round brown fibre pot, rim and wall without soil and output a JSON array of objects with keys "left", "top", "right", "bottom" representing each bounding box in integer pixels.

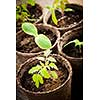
[{"left": 17, "top": 54, "right": 72, "bottom": 100}]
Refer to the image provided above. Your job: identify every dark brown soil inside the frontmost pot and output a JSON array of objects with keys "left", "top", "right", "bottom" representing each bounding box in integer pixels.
[{"left": 21, "top": 63, "right": 68, "bottom": 92}]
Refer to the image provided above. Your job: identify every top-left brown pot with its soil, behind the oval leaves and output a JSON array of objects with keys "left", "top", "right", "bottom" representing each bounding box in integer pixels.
[{"left": 16, "top": 3, "right": 43, "bottom": 32}]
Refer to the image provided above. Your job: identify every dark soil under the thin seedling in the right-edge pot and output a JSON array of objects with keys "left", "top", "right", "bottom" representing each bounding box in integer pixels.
[{"left": 63, "top": 43, "right": 83, "bottom": 58}]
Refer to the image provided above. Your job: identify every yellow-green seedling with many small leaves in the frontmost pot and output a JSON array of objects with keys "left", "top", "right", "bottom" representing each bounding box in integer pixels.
[{"left": 28, "top": 49, "right": 58, "bottom": 88}]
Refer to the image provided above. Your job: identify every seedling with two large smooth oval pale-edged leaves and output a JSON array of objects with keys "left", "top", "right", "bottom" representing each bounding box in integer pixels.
[{"left": 22, "top": 22, "right": 52, "bottom": 50}]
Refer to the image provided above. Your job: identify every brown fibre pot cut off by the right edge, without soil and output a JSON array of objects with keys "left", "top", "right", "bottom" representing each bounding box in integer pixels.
[{"left": 58, "top": 27, "right": 83, "bottom": 100}]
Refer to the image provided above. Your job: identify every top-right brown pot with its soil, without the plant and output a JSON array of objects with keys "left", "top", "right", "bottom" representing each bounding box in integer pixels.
[{"left": 43, "top": 4, "right": 83, "bottom": 35}]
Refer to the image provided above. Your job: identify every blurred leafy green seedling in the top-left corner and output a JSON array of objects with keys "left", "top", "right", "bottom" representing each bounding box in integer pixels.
[{"left": 16, "top": 0, "right": 35, "bottom": 22}]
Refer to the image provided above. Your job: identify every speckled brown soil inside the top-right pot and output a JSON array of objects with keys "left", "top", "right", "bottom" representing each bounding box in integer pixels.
[{"left": 48, "top": 11, "right": 82, "bottom": 28}]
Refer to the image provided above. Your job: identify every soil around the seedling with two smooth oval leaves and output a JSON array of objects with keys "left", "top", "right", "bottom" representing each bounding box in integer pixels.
[{"left": 16, "top": 29, "right": 57, "bottom": 53}]
